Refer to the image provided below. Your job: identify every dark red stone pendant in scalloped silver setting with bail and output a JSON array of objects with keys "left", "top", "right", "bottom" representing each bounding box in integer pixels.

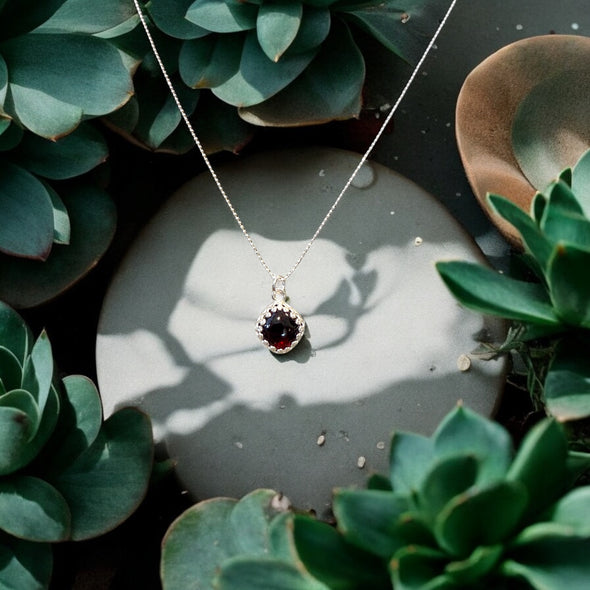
[{"left": 256, "top": 277, "right": 305, "bottom": 354}]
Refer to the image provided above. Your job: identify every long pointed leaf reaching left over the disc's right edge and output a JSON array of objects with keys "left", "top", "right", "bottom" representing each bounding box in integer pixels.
[{"left": 436, "top": 261, "right": 561, "bottom": 328}]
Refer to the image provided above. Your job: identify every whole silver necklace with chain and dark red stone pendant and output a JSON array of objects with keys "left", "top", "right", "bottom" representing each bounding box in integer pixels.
[{"left": 133, "top": 0, "right": 457, "bottom": 354}]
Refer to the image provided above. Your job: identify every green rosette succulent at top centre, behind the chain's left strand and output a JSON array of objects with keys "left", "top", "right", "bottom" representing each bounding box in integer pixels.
[{"left": 112, "top": 0, "right": 448, "bottom": 151}]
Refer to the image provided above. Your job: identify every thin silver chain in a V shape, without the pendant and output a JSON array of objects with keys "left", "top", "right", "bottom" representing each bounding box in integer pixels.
[{"left": 133, "top": 0, "right": 457, "bottom": 281}]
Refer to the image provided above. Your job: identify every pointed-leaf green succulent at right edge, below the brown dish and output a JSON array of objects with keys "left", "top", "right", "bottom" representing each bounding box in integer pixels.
[{"left": 437, "top": 151, "right": 590, "bottom": 420}]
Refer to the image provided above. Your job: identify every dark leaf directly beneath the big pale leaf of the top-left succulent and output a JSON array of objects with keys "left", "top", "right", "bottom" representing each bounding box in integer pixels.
[{"left": 14, "top": 123, "right": 108, "bottom": 180}]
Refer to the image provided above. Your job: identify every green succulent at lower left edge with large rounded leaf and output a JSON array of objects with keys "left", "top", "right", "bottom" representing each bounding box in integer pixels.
[{"left": 0, "top": 303, "right": 153, "bottom": 590}]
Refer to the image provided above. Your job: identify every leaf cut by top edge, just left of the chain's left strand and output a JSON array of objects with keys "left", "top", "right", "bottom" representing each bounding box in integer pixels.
[{"left": 36, "top": 0, "right": 135, "bottom": 34}]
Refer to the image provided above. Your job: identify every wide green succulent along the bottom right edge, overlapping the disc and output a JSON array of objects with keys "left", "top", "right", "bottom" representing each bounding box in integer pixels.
[{"left": 161, "top": 405, "right": 590, "bottom": 590}]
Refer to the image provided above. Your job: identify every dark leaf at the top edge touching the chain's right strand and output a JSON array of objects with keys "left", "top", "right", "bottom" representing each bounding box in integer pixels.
[{"left": 338, "top": 0, "right": 447, "bottom": 63}]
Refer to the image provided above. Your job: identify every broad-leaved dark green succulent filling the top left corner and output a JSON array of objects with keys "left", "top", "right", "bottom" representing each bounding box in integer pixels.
[{"left": 0, "top": 0, "right": 136, "bottom": 307}]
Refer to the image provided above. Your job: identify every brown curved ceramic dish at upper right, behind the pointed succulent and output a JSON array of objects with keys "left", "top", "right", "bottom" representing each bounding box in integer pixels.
[{"left": 456, "top": 35, "right": 590, "bottom": 245}]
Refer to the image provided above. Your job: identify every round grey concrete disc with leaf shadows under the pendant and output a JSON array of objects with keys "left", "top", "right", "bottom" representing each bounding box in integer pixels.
[{"left": 97, "top": 149, "right": 505, "bottom": 514}]
